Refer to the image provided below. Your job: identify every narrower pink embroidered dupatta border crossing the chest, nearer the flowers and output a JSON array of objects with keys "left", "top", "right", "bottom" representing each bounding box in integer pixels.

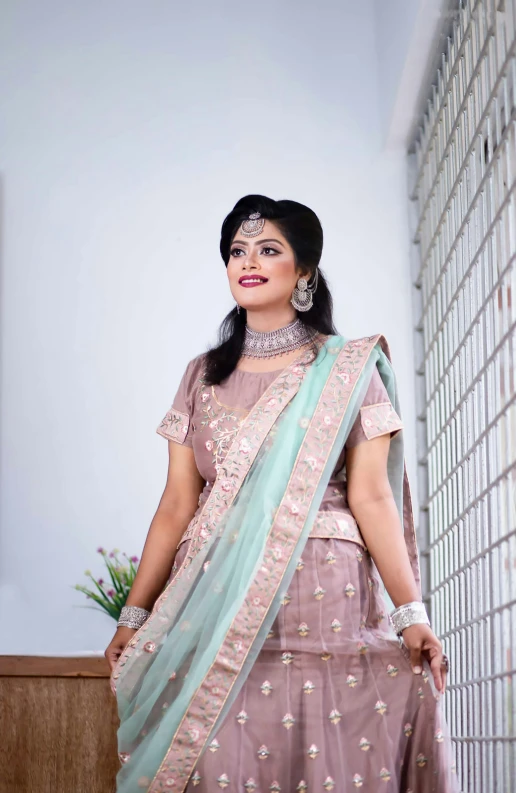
[{"left": 110, "top": 335, "right": 328, "bottom": 695}]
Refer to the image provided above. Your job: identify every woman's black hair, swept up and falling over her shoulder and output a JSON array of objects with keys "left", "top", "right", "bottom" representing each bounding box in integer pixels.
[{"left": 205, "top": 195, "right": 337, "bottom": 385}]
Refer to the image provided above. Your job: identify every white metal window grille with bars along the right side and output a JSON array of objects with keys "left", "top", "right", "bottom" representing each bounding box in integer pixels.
[{"left": 411, "top": 0, "right": 516, "bottom": 793}]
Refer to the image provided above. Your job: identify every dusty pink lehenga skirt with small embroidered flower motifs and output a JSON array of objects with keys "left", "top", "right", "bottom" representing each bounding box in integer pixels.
[{"left": 174, "top": 538, "right": 457, "bottom": 793}]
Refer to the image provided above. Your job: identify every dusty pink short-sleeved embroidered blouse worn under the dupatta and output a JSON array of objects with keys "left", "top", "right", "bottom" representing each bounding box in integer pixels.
[{"left": 157, "top": 353, "right": 403, "bottom": 514}]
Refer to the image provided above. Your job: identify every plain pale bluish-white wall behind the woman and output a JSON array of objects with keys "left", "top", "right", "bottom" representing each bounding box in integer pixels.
[{"left": 0, "top": 0, "right": 414, "bottom": 654}]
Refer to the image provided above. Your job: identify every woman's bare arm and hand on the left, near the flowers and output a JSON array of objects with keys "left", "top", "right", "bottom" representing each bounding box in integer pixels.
[{"left": 105, "top": 441, "right": 205, "bottom": 669}]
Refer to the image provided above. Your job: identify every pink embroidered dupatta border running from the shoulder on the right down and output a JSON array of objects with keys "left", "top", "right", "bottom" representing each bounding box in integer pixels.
[{"left": 147, "top": 335, "right": 382, "bottom": 793}]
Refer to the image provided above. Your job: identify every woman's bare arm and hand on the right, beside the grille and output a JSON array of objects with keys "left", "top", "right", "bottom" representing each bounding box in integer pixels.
[{"left": 346, "top": 434, "right": 446, "bottom": 692}]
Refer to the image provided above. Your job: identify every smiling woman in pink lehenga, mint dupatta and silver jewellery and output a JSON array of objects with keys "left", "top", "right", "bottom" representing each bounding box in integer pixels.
[{"left": 106, "top": 196, "right": 454, "bottom": 793}]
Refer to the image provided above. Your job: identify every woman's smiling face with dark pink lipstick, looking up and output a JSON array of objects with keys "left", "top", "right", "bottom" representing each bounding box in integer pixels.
[{"left": 227, "top": 220, "right": 300, "bottom": 311}]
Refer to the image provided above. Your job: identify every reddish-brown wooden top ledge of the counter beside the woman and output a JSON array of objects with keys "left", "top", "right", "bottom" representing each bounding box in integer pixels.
[{"left": 0, "top": 655, "right": 110, "bottom": 677}]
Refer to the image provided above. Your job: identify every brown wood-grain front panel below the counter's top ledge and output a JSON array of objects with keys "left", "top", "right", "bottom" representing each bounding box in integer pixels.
[{"left": 0, "top": 659, "right": 120, "bottom": 793}]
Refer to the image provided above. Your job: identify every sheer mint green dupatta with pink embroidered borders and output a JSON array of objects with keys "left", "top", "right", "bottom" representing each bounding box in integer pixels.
[{"left": 112, "top": 336, "right": 418, "bottom": 793}]
